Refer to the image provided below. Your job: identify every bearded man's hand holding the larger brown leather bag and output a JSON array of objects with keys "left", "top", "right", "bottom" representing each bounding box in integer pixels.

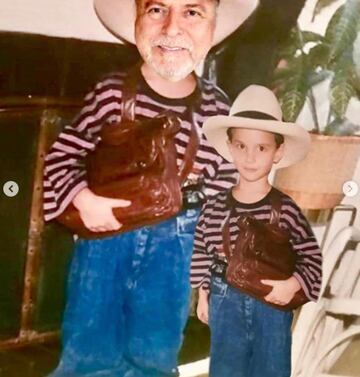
[{"left": 73, "top": 188, "right": 131, "bottom": 232}]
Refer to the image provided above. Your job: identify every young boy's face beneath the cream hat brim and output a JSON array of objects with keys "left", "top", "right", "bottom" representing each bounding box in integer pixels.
[{"left": 228, "top": 128, "right": 284, "bottom": 182}]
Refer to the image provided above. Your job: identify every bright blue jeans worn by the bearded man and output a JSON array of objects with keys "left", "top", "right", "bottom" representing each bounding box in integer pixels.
[{"left": 51, "top": 209, "right": 199, "bottom": 377}]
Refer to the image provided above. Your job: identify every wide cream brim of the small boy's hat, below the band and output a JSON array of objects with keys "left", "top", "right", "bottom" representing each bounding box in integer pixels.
[{"left": 203, "top": 115, "right": 311, "bottom": 169}]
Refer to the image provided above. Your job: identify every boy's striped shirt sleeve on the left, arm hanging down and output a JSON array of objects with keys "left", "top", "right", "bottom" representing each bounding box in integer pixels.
[{"left": 190, "top": 202, "right": 214, "bottom": 289}]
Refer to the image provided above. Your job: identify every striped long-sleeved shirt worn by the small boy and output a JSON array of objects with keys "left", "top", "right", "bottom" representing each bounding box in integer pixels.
[{"left": 191, "top": 188, "right": 322, "bottom": 301}]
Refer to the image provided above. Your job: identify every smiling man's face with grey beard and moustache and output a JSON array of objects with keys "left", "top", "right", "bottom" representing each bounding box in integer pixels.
[{"left": 135, "top": 0, "right": 217, "bottom": 81}]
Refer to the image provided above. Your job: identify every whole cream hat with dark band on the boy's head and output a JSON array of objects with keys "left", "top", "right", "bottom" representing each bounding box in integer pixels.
[{"left": 203, "top": 85, "right": 311, "bottom": 169}]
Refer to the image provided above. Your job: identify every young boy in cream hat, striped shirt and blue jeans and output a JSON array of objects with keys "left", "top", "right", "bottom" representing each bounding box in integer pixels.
[{"left": 191, "top": 85, "right": 322, "bottom": 377}]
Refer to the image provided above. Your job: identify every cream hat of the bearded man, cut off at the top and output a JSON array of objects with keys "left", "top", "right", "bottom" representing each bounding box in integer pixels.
[{"left": 94, "top": 0, "right": 258, "bottom": 45}]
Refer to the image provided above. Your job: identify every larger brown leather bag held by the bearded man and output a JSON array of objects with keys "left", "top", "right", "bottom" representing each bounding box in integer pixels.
[{"left": 57, "top": 67, "right": 199, "bottom": 238}]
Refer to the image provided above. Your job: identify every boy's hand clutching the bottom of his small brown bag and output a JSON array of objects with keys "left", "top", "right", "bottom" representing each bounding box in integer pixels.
[{"left": 261, "top": 276, "right": 301, "bottom": 305}]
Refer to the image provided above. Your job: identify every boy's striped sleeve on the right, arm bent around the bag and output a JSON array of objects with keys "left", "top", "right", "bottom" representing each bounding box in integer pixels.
[{"left": 285, "top": 204, "right": 322, "bottom": 301}]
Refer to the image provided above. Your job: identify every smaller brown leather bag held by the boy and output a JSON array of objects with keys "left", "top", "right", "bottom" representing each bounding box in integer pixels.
[{"left": 222, "top": 189, "right": 309, "bottom": 310}]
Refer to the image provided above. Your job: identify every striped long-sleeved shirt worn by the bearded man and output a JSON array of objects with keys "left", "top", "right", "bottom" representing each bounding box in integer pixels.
[{"left": 44, "top": 73, "right": 237, "bottom": 221}]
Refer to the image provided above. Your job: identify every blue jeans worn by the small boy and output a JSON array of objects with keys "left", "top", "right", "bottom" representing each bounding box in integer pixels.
[{"left": 209, "top": 276, "right": 293, "bottom": 377}]
